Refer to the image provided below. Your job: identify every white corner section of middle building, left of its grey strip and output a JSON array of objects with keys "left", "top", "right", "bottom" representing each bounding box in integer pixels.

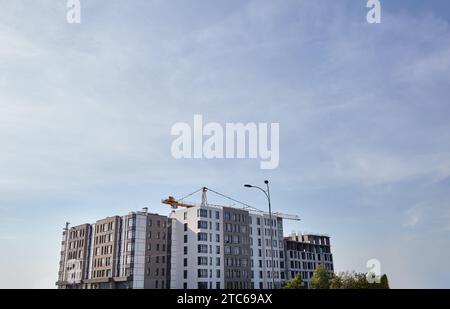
[{"left": 170, "top": 207, "right": 224, "bottom": 289}]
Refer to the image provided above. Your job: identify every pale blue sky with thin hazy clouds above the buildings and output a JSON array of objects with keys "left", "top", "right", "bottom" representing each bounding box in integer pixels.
[{"left": 0, "top": 0, "right": 450, "bottom": 288}]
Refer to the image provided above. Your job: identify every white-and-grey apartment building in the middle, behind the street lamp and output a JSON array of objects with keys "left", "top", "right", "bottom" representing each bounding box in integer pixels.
[{"left": 170, "top": 205, "right": 286, "bottom": 289}]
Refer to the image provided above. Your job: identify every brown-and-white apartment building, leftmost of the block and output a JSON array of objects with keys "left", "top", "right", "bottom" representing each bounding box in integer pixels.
[{"left": 56, "top": 208, "right": 168, "bottom": 289}]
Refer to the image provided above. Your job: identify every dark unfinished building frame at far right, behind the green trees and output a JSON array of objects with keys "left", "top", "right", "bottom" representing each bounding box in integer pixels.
[{"left": 284, "top": 234, "right": 334, "bottom": 286}]
